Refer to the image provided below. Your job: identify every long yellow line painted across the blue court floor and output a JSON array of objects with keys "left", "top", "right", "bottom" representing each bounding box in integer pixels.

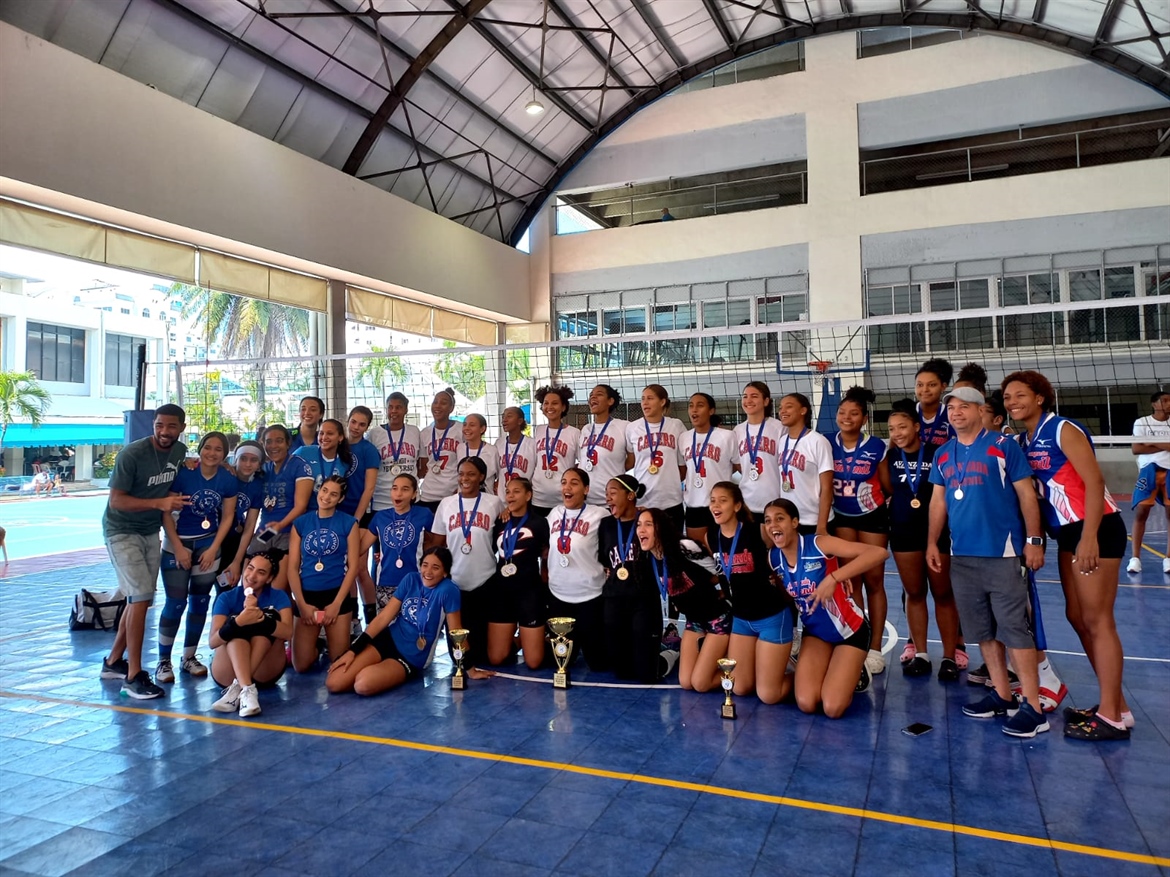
[{"left": 0, "top": 691, "right": 1170, "bottom": 866}]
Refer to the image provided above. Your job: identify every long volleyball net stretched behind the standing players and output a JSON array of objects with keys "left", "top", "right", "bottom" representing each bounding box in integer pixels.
[{"left": 167, "top": 293, "right": 1170, "bottom": 444}]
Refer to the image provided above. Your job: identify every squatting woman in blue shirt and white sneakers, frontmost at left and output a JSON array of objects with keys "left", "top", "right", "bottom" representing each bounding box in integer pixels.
[{"left": 211, "top": 554, "right": 293, "bottom": 716}]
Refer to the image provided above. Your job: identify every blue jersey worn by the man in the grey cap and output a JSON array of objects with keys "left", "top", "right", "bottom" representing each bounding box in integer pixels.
[{"left": 930, "top": 429, "right": 1032, "bottom": 558}]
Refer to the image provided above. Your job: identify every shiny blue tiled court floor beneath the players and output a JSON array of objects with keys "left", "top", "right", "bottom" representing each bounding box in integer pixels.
[{"left": 0, "top": 521, "right": 1170, "bottom": 877}]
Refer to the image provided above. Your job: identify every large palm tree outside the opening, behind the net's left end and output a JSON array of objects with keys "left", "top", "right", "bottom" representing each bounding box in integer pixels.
[{"left": 171, "top": 283, "right": 309, "bottom": 426}]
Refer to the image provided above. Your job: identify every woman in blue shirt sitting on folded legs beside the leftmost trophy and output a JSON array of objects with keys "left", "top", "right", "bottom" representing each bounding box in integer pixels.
[{"left": 325, "top": 546, "right": 467, "bottom": 697}]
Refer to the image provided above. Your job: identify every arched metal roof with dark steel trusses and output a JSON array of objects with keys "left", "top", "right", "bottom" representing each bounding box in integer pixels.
[{"left": 0, "top": 0, "right": 1170, "bottom": 242}]
